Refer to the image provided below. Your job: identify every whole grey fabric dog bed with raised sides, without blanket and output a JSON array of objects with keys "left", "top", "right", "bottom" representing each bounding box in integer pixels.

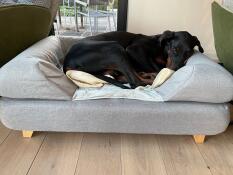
[{"left": 0, "top": 37, "right": 233, "bottom": 142}]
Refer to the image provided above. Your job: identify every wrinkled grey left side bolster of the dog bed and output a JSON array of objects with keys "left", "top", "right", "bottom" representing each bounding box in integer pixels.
[{"left": 0, "top": 37, "right": 77, "bottom": 100}]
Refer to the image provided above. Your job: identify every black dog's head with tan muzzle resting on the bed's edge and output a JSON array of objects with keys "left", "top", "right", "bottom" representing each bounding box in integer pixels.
[{"left": 159, "top": 31, "right": 204, "bottom": 71}]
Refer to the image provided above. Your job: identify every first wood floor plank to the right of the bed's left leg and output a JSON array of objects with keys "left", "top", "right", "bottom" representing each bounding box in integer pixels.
[{"left": 28, "top": 133, "right": 83, "bottom": 175}]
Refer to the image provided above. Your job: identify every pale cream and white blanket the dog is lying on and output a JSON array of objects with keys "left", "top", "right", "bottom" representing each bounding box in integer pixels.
[{"left": 71, "top": 68, "right": 174, "bottom": 102}]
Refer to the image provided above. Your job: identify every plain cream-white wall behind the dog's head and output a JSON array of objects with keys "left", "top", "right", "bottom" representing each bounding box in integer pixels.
[{"left": 128, "top": 0, "right": 222, "bottom": 59}]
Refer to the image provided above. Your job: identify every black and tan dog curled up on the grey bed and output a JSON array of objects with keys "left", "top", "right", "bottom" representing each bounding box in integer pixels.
[{"left": 63, "top": 31, "right": 204, "bottom": 88}]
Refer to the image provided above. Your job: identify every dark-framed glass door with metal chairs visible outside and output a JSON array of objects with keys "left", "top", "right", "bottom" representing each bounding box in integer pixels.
[{"left": 54, "top": 0, "right": 128, "bottom": 37}]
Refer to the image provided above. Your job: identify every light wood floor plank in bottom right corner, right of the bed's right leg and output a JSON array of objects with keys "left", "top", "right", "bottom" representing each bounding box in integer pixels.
[{"left": 198, "top": 126, "right": 233, "bottom": 175}]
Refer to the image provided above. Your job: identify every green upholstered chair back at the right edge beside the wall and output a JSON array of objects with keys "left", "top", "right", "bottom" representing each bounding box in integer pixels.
[{"left": 212, "top": 2, "right": 233, "bottom": 74}]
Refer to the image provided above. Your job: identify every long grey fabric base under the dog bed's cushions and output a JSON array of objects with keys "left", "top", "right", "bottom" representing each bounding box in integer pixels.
[{"left": 0, "top": 98, "right": 230, "bottom": 135}]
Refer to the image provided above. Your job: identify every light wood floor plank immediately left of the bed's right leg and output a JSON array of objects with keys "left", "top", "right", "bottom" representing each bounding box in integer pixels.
[{"left": 159, "top": 136, "right": 211, "bottom": 175}]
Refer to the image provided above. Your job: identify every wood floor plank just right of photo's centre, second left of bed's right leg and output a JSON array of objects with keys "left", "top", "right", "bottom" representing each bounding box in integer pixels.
[{"left": 121, "top": 134, "right": 166, "bottom": 175}]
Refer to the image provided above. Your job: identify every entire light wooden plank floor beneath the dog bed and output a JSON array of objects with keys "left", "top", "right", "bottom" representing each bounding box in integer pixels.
[{"left": 0, "top": 123, "right": 233, "bottom": 175}]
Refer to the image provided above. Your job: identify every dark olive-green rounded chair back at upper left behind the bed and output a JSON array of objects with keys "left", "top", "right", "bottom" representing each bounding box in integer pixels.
[{"left": 0, "top": 5, "right": 51, "bottom": 67}]
